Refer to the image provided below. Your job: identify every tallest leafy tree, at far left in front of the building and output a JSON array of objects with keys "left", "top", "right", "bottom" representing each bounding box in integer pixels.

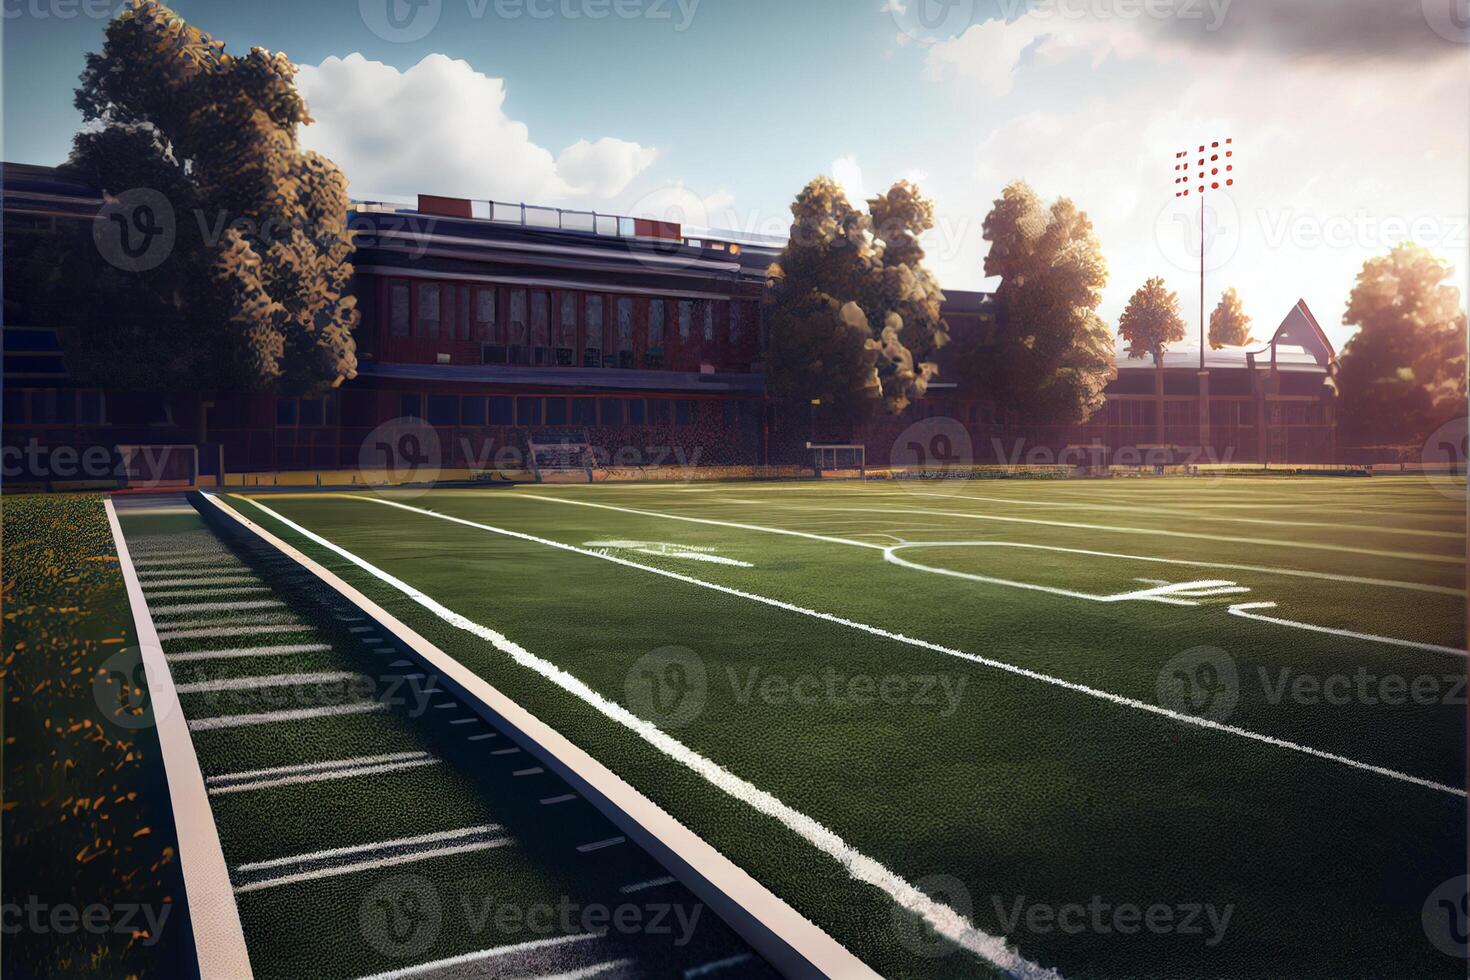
[{"left": 62, "top": 0, "right": 357, "bottom": 394}]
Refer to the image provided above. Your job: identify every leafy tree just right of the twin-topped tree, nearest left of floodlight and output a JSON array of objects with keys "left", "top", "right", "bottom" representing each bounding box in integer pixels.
[{"left": 954, "top": 181, "right": 1116, "bottom": 423}]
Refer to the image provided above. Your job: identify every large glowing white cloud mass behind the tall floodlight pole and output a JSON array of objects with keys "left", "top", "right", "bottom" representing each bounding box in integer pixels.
[{"left": 925, "top": 7, "right": 1470, "bottom": 351}]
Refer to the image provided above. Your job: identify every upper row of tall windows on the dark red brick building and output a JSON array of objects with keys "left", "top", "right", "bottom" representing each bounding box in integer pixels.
[{"left": 388, "top": 279, "right": 754, "bottom": 354}]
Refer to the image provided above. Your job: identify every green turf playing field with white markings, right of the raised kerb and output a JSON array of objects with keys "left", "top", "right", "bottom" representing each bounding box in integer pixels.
[{"left": 213, "top": 478, "right": 1466, "bottom": 977}]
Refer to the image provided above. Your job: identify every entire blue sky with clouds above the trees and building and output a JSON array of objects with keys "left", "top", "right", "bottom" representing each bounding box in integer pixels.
[{"left": 3, "top": 0, "right": 1470, "bottom": 342}]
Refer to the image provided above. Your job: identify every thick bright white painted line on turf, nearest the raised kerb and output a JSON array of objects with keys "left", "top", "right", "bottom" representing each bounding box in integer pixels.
[{"left": 240, "top": 497, "right": 1060, "bottom": 980}]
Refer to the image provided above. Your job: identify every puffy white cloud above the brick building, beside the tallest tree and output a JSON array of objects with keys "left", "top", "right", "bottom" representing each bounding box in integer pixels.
[{"left": 297, "top": 54, "right": 659, "bottom": 204}]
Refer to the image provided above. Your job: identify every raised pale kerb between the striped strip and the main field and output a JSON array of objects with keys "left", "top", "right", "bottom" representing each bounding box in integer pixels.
[{"left": 201, "top": 494, "right": 882, "bottom": 980}]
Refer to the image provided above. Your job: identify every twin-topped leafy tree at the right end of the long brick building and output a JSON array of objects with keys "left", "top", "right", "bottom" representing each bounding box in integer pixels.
[{"left": 767, "top": 176, "right": 948, "bottom": 422}]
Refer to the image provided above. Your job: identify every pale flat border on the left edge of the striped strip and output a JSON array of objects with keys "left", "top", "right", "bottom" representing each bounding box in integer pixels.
[{"left": 103, "top": 500, "right": 254, "bottom": 980}]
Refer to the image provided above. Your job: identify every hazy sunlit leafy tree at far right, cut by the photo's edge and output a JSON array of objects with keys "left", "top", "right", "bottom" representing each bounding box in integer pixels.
[{"left": 1338, "top": 242, "right": 1466, "bottom": 445}]
